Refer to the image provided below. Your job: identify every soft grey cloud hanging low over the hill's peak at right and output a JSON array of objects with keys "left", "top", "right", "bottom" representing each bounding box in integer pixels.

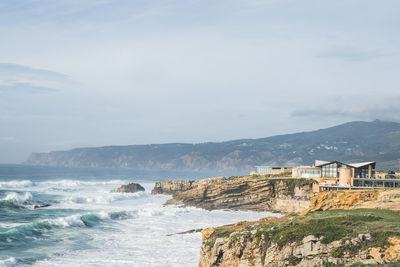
[{"left": 291, "top": 96, "right": 400, "bottom": 121}]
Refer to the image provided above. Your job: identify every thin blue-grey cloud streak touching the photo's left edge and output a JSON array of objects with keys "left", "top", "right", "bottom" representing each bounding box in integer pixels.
[{"left": 0, "top": 63, "right": 70, "bottom": 81}]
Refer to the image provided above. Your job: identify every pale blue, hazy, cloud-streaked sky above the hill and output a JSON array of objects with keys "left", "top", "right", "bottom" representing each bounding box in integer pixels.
[{"left": 0, "top": 0, "right": 400, "bottom": 163}]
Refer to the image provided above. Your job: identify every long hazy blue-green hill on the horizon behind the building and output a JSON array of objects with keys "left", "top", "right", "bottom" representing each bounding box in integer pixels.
[{"left": 24, "top": 120, "right": 400, "bottom": 171}]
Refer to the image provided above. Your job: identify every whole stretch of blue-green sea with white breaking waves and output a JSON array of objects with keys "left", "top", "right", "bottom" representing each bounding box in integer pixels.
[{"left": 0, "top": 165, "right": 278, "bottom": 266}]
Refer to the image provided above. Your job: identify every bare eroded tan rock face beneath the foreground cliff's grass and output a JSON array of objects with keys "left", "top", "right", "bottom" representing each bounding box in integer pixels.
[{"left": 199, "top": 232, "right": 383, "bottom": 267}]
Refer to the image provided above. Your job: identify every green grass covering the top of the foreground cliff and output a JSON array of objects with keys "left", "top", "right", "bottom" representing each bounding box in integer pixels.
[{"left": 211, "top": 209, "right": 400, "bottom": 260}]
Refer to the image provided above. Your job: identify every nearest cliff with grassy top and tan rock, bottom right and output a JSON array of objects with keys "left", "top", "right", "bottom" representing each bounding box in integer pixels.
[{"left": 199, "top": 210, "right": 400, "bottom": 267}]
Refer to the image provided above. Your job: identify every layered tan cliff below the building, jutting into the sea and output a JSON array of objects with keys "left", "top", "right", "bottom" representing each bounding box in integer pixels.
[{"left": 152, "top": 176, "right": 314, "bottom": 213}]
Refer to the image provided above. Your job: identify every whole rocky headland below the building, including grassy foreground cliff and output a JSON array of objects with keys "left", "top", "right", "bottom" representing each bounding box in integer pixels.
[{"left": 152, "top": 176, "right": 400, "bottom": 267}]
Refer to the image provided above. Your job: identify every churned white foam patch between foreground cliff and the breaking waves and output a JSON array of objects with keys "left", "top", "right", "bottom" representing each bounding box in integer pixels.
[{"left": 35, "top": 199, "right": 274, "bottom": 267}]
